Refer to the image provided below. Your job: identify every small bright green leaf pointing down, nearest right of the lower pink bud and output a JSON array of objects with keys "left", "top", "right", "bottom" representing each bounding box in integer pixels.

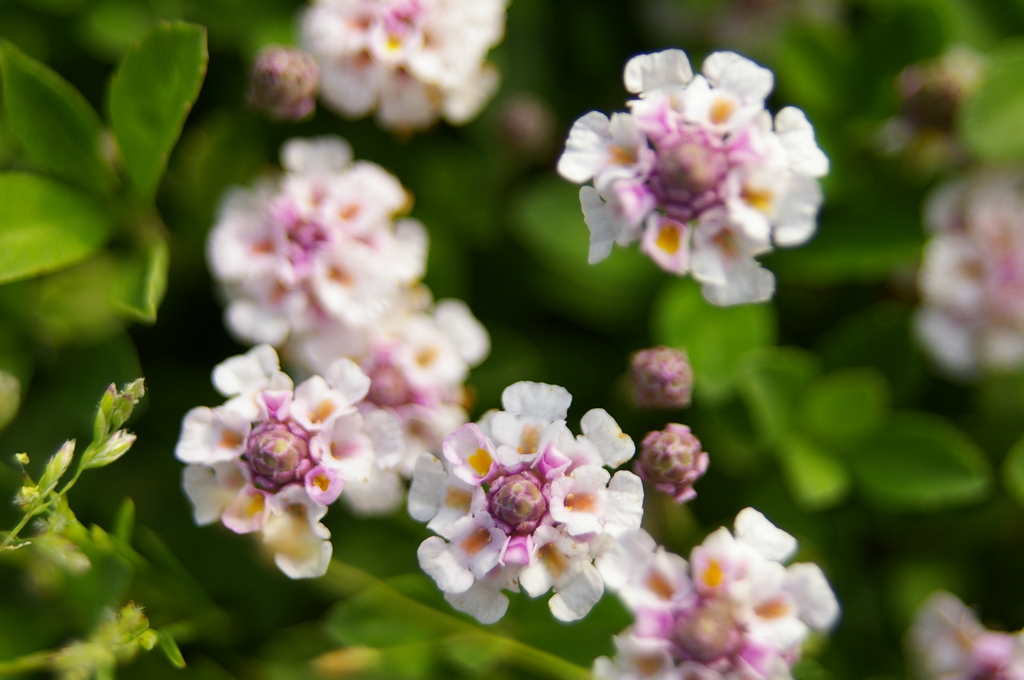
[{"left": 778, "top": 437, "right": 851, "bottom": 510}]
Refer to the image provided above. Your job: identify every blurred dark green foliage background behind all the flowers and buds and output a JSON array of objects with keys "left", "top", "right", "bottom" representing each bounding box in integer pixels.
[{"left": 0, "top": 0, "right": 1024, "bottom": 680}]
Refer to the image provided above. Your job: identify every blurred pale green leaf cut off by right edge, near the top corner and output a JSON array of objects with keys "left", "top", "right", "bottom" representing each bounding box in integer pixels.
[{"left": 959, "top": 40, "right": 1024, "bottom": 161}]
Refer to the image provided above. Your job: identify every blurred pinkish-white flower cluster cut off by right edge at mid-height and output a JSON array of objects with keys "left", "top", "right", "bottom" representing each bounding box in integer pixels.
[{"left": 915, "top": 170, "right": 1024, "bottom": 377}]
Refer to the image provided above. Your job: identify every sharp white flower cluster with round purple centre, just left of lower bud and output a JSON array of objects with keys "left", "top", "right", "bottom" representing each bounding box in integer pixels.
[{"left": 409, "top": 382, "right": 643, "bottom": 623}]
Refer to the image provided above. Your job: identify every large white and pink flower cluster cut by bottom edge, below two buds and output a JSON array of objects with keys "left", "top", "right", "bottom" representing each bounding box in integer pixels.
[{"left": 594, "top": 508, "right": 839, "bottom": 680}]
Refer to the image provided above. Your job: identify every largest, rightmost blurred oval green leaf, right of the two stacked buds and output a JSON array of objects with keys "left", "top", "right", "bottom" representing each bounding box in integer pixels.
[{"left": 849, "top": 411, "right": 991, "bottom": 510}]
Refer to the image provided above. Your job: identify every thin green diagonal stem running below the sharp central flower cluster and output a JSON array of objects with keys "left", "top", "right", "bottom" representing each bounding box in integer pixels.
[{"left": 317, "top": 559, "right": 591, "bottom": 680}]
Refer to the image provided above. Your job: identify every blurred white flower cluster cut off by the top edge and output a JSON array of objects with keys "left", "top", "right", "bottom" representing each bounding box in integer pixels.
[{"left": 302, "top": 0, "right": 508, "bottom": 130}]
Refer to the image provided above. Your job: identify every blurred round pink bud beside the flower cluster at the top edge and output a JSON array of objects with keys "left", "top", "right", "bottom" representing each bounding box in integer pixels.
[{"left": 249, "top": 45, "right": 319, "bottom": 121}]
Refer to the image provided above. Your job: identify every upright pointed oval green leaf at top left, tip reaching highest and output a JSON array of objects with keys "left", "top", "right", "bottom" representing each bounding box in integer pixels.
[{"left": 110, "top": 22, "right": 209, "bottom": 201}]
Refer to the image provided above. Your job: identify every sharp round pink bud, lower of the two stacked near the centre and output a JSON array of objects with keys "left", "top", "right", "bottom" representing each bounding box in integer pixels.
[{"left": 634, "top": 423, "right": 708, "bottom": 503}]
